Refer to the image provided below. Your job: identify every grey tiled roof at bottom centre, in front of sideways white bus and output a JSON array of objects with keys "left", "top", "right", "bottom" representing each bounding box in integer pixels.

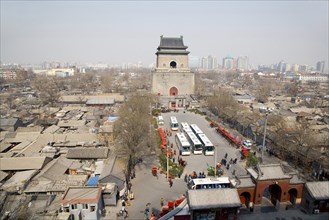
[{"left": 187, "top": 189, "right": 241, "bottom": 210}]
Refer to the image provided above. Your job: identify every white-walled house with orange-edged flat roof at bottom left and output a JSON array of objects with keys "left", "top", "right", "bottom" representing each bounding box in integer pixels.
[{"left": 61, "top": 187, "right": 105, "bottom": 220}]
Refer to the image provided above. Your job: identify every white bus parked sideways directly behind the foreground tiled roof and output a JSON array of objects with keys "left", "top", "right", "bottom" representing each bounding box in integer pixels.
[{"left": 188, "top": 177, "right": 232, "bottom": 190}]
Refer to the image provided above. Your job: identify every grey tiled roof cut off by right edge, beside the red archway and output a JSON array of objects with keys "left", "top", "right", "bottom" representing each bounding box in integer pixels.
[{"left": 305, "top": 181, "right": 329, "bottom": 200}]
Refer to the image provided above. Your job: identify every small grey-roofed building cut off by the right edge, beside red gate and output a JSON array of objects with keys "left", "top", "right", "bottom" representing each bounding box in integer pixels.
[{"left": 302, "top": 181, "right": 329, "bottom": 214}]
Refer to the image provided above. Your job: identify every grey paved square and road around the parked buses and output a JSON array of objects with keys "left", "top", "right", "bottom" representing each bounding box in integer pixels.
[{"left": 118, "top": 111, "right": 307, "bottom": 220}]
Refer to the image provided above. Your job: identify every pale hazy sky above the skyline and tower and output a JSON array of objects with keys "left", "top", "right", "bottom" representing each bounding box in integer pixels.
[{"left": 1, "top": 0, "right": 329, "bottom": 67}]
